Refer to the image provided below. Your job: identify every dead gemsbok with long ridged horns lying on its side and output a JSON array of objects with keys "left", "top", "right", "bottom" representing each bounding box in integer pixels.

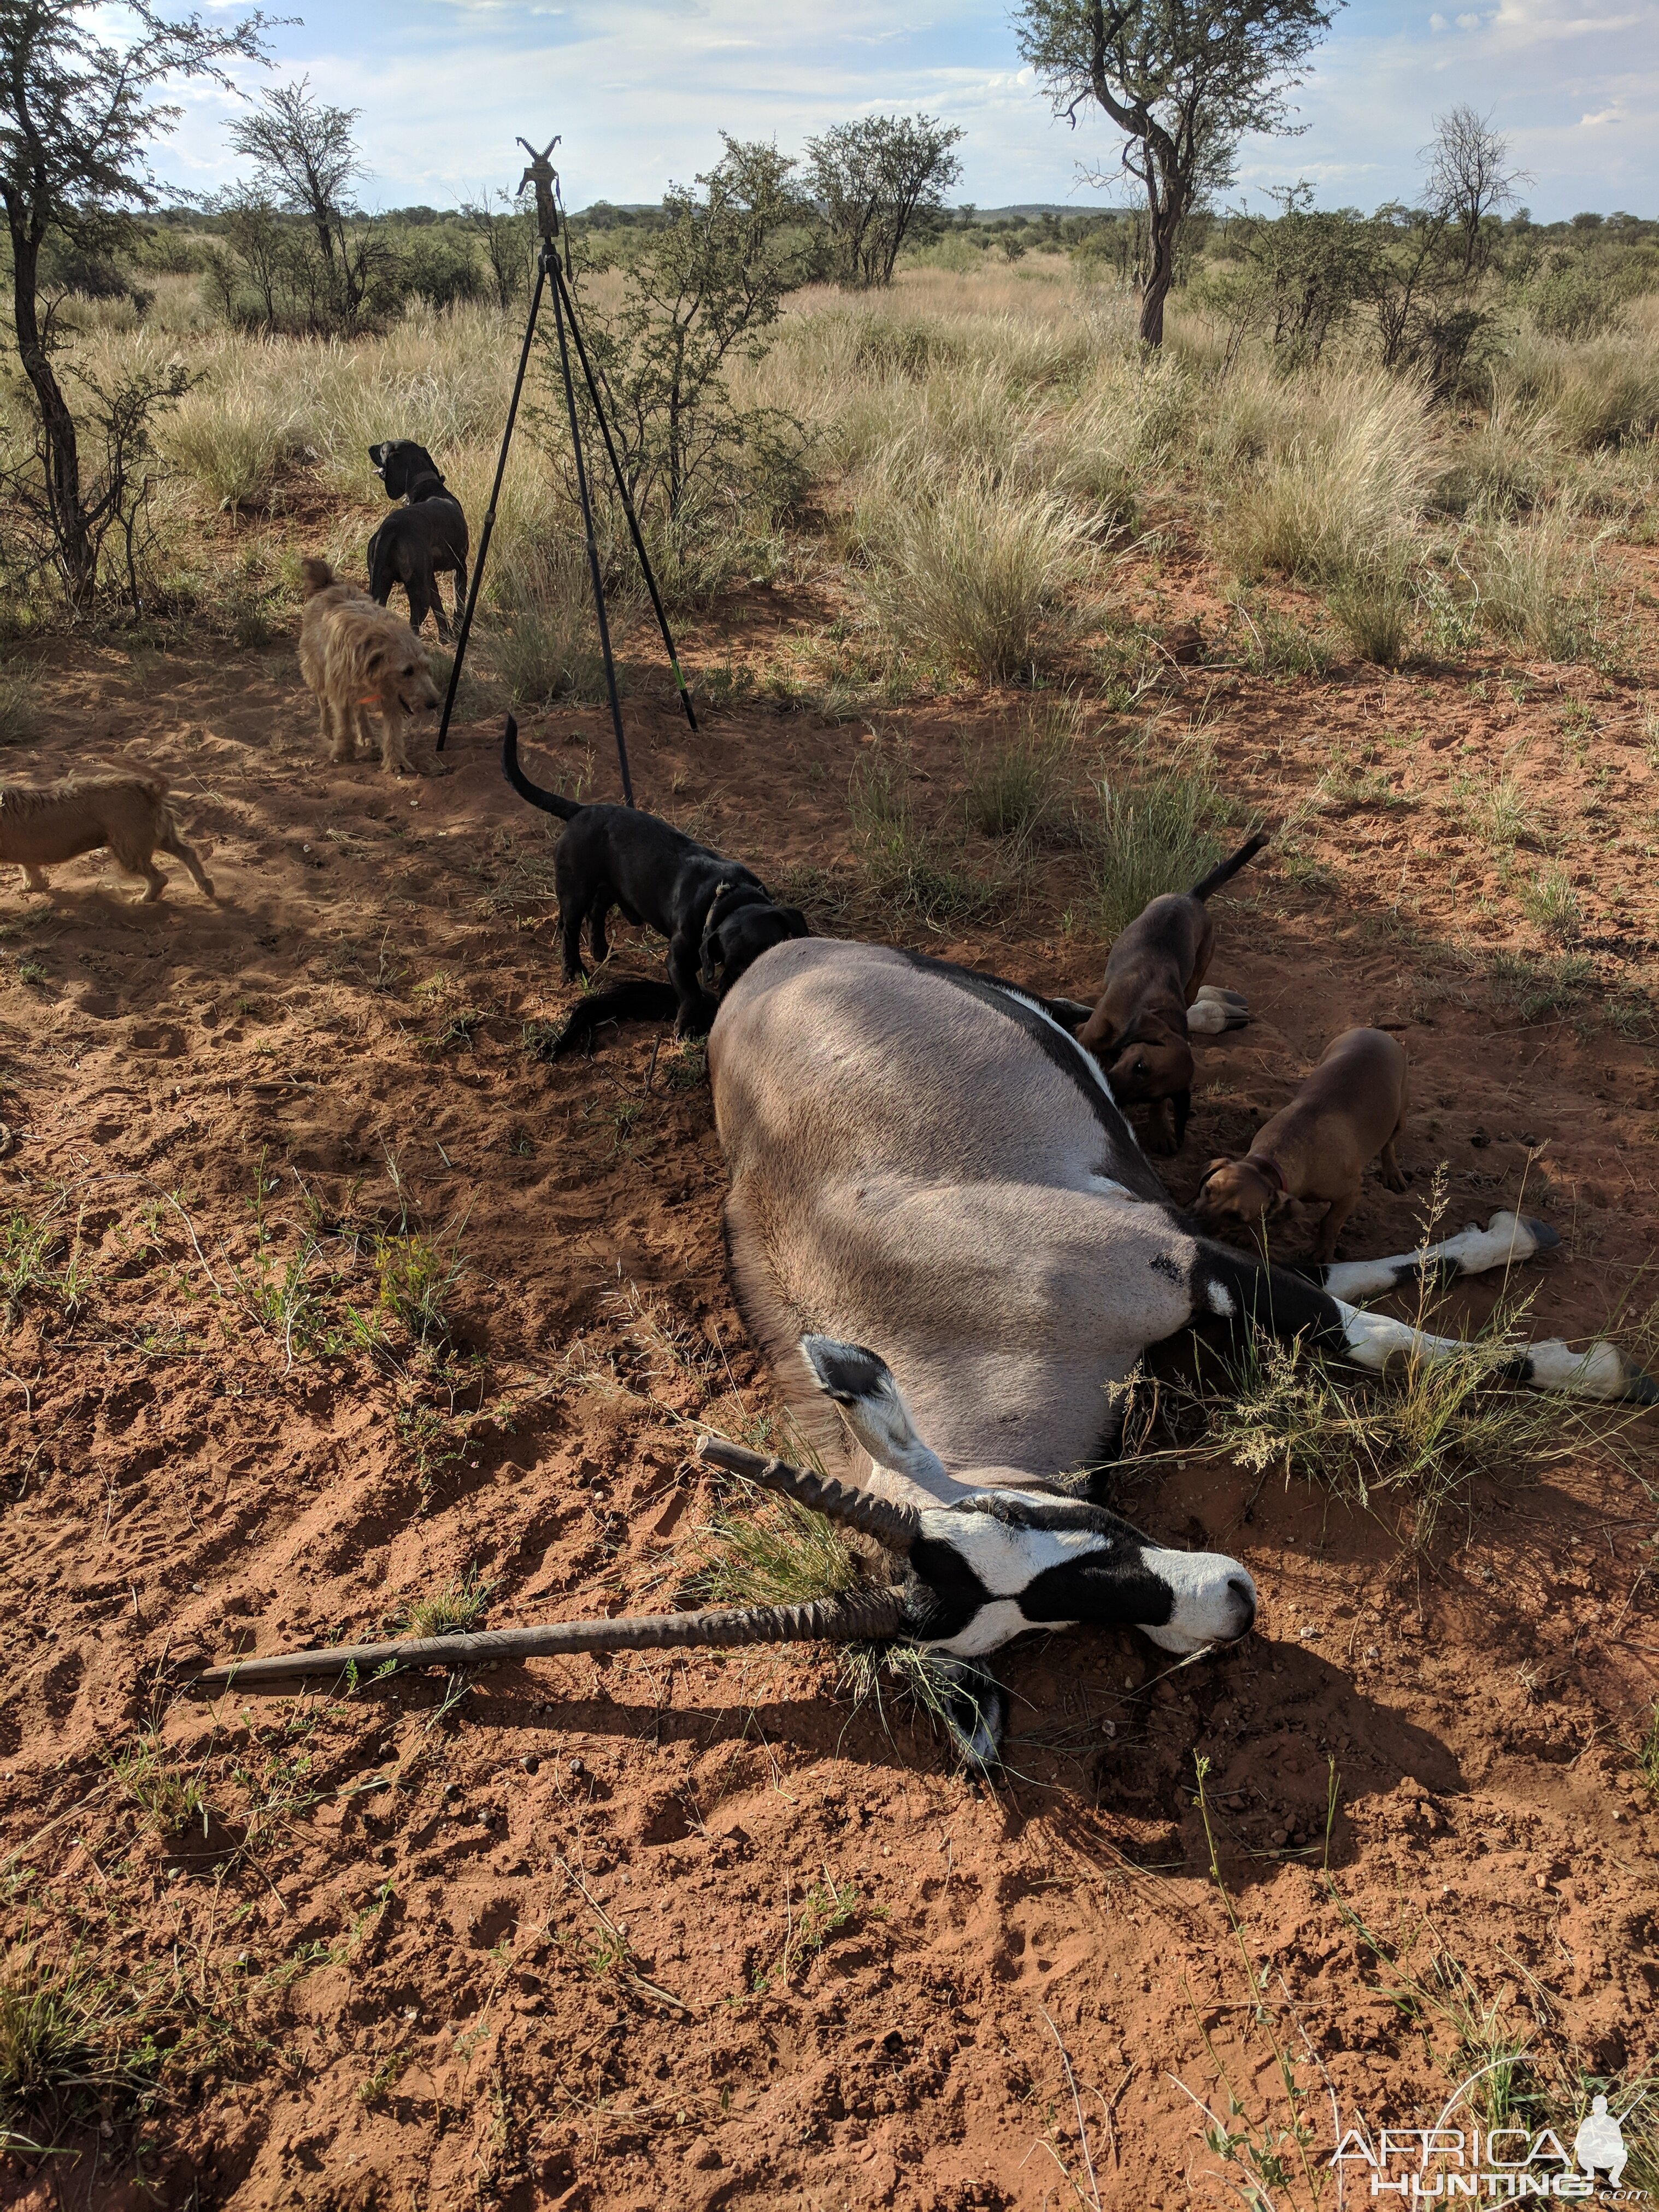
[{"left": 199, "top": 938, "right": 1659, "bottom": 1761}]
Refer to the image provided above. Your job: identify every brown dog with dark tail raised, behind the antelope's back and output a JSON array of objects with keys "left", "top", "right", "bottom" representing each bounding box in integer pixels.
[{"left": 1077, "top": 836, "right": 1268, "bottom": 1152}]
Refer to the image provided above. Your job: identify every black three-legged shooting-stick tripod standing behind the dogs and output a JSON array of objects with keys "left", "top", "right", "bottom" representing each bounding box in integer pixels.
[{"left": 438, "top": 139, "right": 697, "bottom": 805}]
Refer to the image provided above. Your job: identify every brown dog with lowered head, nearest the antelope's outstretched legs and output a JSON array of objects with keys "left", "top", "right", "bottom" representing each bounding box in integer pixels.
[{"left": 1192, "top": 1028, "right": 1407, "bottom": 1258}]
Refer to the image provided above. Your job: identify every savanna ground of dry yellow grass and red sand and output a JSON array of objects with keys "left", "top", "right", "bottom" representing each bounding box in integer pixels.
[{"left": 0, "top": 177, "right": 1659, "bottom": 2212}]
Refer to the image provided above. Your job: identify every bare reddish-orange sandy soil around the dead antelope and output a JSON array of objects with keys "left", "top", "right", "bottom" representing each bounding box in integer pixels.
[{"left": 0, "top": 566, "right": 1659, "bottom": 2212}]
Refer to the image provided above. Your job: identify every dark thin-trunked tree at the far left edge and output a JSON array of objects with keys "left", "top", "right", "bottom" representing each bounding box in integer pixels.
[{"left": 0, "top": 0, "right": 263, "bottom": 610}]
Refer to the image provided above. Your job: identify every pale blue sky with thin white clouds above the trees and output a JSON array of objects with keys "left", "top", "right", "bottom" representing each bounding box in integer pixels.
[{"left": 159, "top": 0, "right": 1659, "bottom": 219}]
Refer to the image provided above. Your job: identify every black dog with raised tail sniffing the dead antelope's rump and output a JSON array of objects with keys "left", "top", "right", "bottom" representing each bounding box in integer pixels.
[{"left": 502, "top": 715, "right": 812, "bottom": 1060}]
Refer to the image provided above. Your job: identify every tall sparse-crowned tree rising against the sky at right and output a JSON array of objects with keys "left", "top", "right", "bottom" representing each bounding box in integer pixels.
[{"left": 1015, "top": 0, "right": 1343, "bottom": 345}]
